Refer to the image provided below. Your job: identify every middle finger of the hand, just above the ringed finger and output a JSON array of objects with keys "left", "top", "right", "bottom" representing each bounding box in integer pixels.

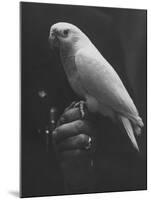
[{"left": 52, "top": 120, "right": 90, "bottom": 143}]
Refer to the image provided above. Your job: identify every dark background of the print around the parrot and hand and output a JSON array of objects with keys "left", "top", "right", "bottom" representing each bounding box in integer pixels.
[{"left": 20, "top": 2, "right": 147, "bottom": 197}]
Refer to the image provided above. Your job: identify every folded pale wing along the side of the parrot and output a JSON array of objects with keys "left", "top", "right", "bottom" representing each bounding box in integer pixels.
[{"left": 75, "top": 47, "right": 138, "bottom": 122}]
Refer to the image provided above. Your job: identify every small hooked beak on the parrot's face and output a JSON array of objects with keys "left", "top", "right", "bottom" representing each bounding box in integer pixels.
[{"left": 48, "top": 30, "right": 59, "bottom": 49}]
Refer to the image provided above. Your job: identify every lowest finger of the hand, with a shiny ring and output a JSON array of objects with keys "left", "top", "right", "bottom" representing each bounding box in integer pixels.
[{"left": 57, "top": 134, "right": 89, "bottom": 151}]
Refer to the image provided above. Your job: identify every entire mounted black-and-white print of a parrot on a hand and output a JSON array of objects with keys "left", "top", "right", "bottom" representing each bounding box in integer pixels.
[{"left": 20, "top": 2, "right": 147, "bottom": 197}]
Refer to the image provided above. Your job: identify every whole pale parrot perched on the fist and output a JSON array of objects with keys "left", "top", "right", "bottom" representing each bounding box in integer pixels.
[{"left": 49, "top": 22, "right": 143, "bottom": 151}]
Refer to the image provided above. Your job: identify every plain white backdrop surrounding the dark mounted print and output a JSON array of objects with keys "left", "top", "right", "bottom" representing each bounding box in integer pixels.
[{"left": 0, "top": 0, "right": 151, "bottom": 200}]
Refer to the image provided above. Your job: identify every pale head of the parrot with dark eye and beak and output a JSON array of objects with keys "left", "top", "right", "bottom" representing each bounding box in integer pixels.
[{"left": 49, "top": 22, "right": 88, "bottom": 47}]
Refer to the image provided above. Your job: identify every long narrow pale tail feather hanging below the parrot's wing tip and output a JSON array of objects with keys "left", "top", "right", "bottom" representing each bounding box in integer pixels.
[{"left": 119, "top": 115, "right": 139, "bottom": 151}]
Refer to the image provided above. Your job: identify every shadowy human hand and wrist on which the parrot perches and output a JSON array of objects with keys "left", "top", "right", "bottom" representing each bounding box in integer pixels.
[{"left": 53, "top": 104, "right": 96, "bottom": 191}]
